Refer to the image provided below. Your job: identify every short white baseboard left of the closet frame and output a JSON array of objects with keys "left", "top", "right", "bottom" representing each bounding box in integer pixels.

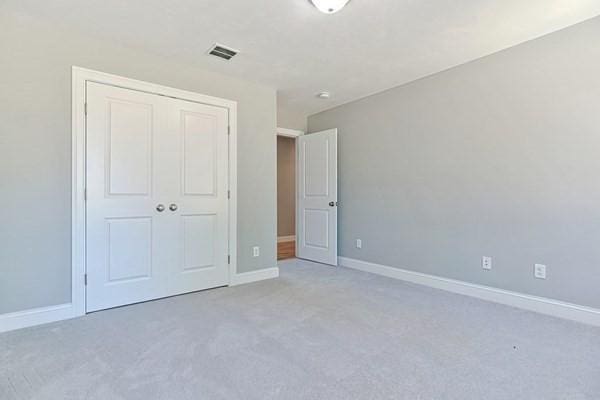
[{"left": 0, "top": 303, "right": 76, "bottom": 332}]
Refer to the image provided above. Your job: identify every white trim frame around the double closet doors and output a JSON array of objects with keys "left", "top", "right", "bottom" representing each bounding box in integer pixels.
[{"left": 71, "top": 66, "right": 237, "bottom": 316}]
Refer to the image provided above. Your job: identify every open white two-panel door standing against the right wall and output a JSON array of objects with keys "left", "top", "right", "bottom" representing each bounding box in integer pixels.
[{"left": 296, "top": 129, "right": 337, "bottom": 265}]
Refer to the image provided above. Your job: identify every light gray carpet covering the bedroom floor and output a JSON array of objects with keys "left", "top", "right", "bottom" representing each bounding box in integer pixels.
[{"left": 0, "top": 260, "right": 600, "bottom": 400}]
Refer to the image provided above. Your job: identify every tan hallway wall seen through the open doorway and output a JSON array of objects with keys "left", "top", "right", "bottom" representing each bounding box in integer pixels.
[{"left": 277, "top": 136, "right": 296, "bottom": 236}]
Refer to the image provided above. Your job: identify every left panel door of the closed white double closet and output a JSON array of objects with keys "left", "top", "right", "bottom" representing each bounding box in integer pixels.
[{"left": 86, "top": 83, "right": 170, "bottom": 311}]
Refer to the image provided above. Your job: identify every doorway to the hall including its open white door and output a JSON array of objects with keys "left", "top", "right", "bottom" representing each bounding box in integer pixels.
[{"left": 277, "top": 128, "right": 338, "bottom": 265}]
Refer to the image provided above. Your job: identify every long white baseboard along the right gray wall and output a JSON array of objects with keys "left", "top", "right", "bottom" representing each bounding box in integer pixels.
[{"left": 338, "top": 257, "right": 600, "bottom": 326}]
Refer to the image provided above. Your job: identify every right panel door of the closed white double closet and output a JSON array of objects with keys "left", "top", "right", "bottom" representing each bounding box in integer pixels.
[{"left": 168, "top": 99, "right": 229, "bottom": 294}]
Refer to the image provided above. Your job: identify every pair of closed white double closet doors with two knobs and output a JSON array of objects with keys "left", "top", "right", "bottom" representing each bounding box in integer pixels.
[{"left": 86, "top": 82, "right": 229, "bottom": 312}]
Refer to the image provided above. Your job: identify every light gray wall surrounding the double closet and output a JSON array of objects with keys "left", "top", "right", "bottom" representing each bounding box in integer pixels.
[{"left": 0, "top": 12, "right": 277, "bottom": 313}]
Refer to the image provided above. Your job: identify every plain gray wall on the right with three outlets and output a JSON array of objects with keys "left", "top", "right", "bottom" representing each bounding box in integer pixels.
[{"left": 308, "top": 18, "right": 600, "bottom": 307}]
